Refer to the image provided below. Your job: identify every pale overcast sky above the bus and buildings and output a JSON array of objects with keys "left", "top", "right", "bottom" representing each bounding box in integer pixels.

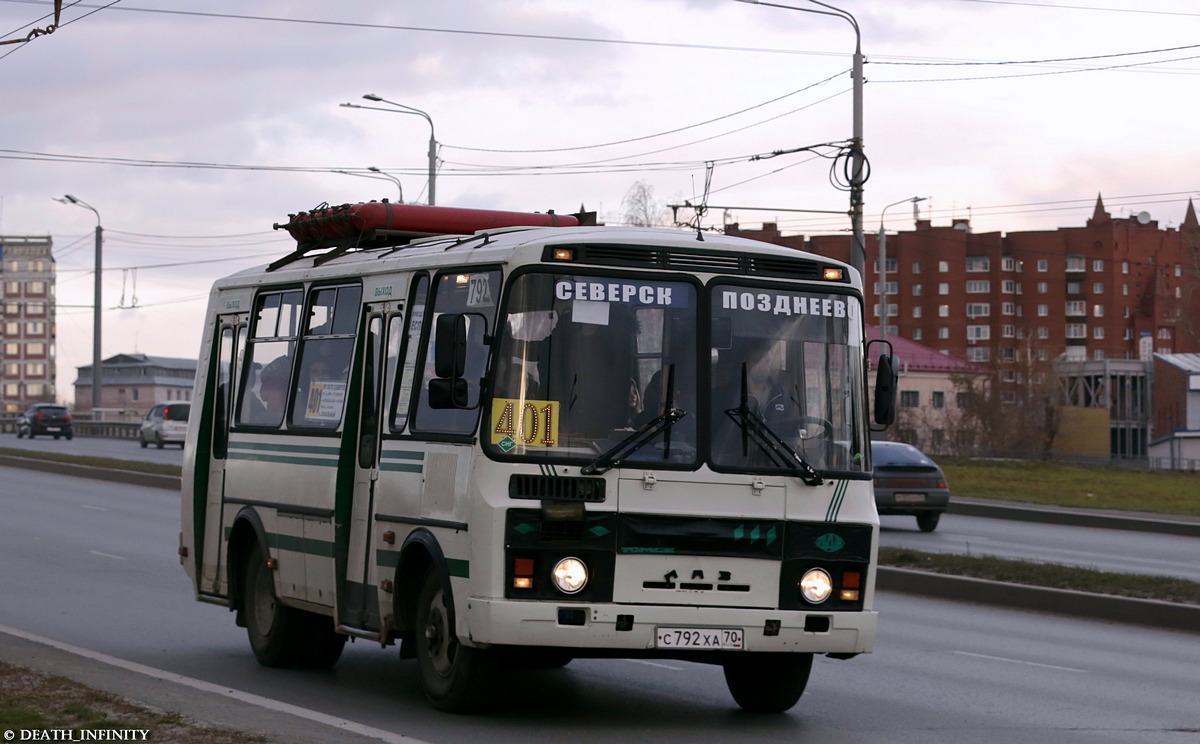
[{"left": 0, "top": 0, "right": 1200, "bottom": 402}]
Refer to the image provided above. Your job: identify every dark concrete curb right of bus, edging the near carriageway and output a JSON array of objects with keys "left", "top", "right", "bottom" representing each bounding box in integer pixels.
[{"left": 875, "top": 565, "right": 1200, "bottom": 632}]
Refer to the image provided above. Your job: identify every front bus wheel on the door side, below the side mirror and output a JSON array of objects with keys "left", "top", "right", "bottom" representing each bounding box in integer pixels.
[{"left": 415, "top": 569, "right": 492, "bottom": 713}]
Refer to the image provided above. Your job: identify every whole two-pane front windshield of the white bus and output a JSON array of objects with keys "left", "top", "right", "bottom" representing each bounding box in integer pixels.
[{"left": 482, "top": 271, "right": 864, "bottom": 472}]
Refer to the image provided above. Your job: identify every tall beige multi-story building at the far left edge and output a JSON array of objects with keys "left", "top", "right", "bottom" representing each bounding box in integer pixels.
[{"left": 0, "top": 235, "right": 56, "bottom": 414}]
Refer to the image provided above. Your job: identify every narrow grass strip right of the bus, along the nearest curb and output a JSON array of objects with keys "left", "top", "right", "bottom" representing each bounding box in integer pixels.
[{"left": 880, "top": 546, "right": 1200, "bottom": 605}]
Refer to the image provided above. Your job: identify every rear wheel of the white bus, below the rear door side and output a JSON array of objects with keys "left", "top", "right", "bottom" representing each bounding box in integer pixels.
[{"left": 242, "top": 545, "right": 311, "bottom": 667}]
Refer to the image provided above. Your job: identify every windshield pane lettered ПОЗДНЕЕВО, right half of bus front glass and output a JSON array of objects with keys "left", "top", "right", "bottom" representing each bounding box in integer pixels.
[{"left": 708, "top": 284, "right": 865, "bottom": 480}]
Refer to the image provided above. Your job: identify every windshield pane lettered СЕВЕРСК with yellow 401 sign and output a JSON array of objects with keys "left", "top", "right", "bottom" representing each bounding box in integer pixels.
[{"left": 484, "top": 272, "right": 697, "bottom": 466}]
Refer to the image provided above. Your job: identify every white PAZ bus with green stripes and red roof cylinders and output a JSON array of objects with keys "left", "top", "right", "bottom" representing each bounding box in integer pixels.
[{"left": 179, "top": 202, "right": 895, "bottom": 712}]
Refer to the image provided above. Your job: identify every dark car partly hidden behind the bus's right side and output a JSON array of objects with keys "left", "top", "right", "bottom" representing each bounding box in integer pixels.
[{"left": 871, "top": 442, "right": 950, "bottom": 532}]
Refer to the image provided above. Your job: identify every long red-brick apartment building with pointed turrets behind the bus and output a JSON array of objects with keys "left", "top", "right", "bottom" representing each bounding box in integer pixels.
[{"left": 726, "top": 198, "right": 1200, "bottom": 370}]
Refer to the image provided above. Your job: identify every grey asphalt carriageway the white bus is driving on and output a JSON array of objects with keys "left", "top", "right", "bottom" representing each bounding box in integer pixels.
[{"left": 0, "top": 468, "right": 1200, "bottom": 744}]
